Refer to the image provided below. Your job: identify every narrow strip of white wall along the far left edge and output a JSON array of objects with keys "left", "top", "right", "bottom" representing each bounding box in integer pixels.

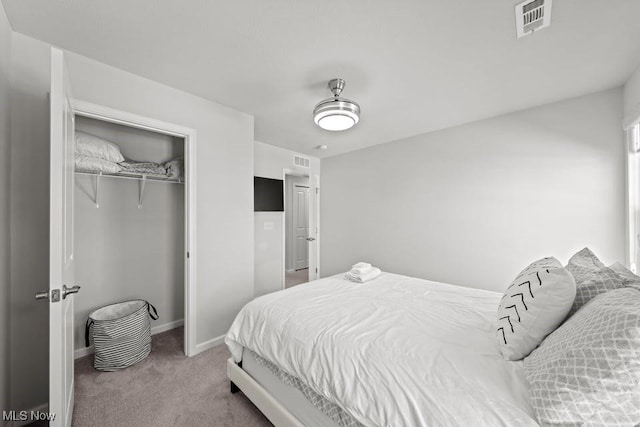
[{"left": 0, "top": 3, "right": 11, "bottom": 411}]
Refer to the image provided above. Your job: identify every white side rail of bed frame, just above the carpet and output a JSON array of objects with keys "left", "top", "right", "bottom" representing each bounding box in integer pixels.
[{"left": 227, "top": 358, "right": 304, "bottom": 427}]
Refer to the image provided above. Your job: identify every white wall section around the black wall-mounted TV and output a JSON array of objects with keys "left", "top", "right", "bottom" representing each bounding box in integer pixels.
[{"left": 254, "top": 141, "right": 320, "bottom": 296}]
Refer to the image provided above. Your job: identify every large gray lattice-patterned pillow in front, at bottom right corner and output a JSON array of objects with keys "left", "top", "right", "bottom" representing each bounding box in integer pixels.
[{"left": 524, "top": 288, "right": 640, "bottom": 426}]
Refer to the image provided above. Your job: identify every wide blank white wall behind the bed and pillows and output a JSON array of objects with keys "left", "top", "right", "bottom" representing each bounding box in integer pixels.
[{"left": 321, "top": 89, "right": 625, "bottom": 292}]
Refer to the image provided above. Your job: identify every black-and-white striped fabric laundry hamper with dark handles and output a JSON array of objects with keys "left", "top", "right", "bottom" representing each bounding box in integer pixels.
[{"left": 84, "top": 300, "right": 158, "bottom": 372}]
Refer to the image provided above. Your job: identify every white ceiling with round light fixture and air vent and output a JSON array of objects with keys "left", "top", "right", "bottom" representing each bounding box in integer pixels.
[{"left": 2, "top": 0, "right": 640, "bottom": 157}]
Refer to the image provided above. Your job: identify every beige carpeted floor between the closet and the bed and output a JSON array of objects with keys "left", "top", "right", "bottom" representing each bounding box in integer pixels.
[{"left": 73, "top": 328, "right": 272, "bottom": 427}]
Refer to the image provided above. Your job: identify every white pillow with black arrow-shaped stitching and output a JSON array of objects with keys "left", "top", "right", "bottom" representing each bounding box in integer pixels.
[{"left": 497, "top": 257, "right": 576, "bottom": 360}]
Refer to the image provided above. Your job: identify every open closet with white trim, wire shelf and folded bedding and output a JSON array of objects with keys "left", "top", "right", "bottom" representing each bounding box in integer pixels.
[{"left": 73, "top": 101, "right": 195, "bottom": 358}]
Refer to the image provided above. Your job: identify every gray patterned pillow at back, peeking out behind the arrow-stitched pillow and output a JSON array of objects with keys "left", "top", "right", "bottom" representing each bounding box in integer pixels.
[{"left": 567, "top": 248, "right": 625, "bottom": 316}]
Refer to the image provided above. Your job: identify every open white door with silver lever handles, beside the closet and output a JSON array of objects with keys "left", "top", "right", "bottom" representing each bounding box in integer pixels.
[{"left": 48, "top": 49, "right": 79, "bottom": 426}]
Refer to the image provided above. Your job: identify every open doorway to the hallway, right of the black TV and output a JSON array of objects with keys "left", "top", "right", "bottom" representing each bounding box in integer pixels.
[{"left": 284, "top": 174, "right": 314, "bottom": 288}]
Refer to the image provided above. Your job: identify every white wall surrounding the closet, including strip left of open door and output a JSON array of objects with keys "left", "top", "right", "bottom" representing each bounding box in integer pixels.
[{"left": 11, "top": 33, "right": 253, "bottom": 409}]
